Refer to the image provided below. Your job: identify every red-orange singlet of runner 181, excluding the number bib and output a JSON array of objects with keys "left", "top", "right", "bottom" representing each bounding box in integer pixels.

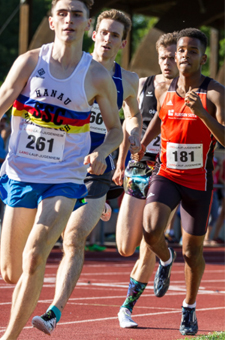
[{"left": 158, "top": 78, "right": 216, "bottom": 191}]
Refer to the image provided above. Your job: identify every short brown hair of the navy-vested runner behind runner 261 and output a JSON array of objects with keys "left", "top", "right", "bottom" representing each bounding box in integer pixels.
[{"left": 95, "top": 9, "right": 132, "bottom": 40}]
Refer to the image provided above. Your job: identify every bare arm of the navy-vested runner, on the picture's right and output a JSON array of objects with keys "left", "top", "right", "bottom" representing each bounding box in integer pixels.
[{"left": 122, "top": 70, "right": 142, "bottom": 153}]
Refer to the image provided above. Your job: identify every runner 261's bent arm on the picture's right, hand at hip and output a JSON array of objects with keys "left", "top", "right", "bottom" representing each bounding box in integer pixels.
[{"left": 84, "top": 60, "right": 123, "bottom": 175}]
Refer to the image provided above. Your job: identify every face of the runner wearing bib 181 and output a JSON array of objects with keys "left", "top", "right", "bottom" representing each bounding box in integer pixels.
[{"left": 176, "top": 37, "right": 206, "bottom": 74}]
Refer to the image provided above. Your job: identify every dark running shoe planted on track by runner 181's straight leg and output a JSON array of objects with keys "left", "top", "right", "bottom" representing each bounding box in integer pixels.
[{"left": 180, "top": 307, "right": 198, "bottom": 335}]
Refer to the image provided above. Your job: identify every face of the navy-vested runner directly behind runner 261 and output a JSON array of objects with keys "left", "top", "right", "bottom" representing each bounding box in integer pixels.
[{"left": 92, "top": 19, "right": 125, "bottom": 58}]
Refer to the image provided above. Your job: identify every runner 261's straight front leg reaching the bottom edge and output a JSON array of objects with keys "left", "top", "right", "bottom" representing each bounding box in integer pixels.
[{"left": 1, "top": 197, "right": 75, "bottom": 340}]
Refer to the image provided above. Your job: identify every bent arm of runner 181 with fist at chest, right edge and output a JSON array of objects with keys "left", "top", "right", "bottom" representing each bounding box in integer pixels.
[{"left": 185, "top": 80, "right": 225, "bottom": 146}]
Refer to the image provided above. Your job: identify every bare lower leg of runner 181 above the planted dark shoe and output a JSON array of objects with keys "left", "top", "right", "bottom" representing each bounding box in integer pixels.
[{"left": 182, "top": 230, "right": 205, "bottom": 305}]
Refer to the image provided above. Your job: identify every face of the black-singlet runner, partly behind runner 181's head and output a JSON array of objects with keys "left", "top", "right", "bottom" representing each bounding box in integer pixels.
[{"left": 158, "top": 45, "right": 178, "bottom": 79}]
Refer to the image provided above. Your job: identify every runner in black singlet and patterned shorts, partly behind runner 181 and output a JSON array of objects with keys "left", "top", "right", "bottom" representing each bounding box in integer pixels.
[{"left": 113, "top": 32, "right": 178, "bottom": 328}]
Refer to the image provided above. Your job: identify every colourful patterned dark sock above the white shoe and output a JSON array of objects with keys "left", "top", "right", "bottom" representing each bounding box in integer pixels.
[{"left": 121, "top": 277, "right": 147, "bottom": 313}]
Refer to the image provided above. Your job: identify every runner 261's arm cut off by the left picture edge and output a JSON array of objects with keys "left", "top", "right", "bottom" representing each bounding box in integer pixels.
[{"left": 0, "top": 50, "right": 39, "bottom": 118}]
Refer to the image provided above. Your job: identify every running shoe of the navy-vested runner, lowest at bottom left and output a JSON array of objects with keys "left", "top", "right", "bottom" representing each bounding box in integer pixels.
[{"left": 32, "top": 310, "right": 56, "bottom": 335}]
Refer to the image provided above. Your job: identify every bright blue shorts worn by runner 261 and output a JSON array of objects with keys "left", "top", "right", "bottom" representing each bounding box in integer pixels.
[{"left": 0, "top": 175, "right": 87, "bottom": 210}]
